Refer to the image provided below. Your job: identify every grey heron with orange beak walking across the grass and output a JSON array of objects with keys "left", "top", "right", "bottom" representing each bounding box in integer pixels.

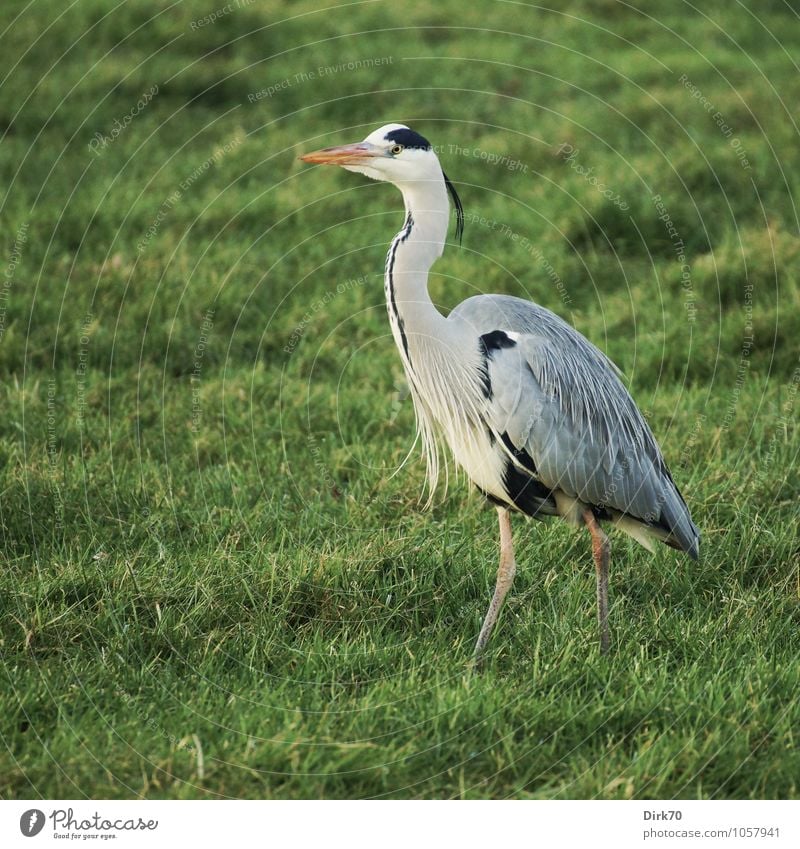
[{"left": 300, "top": 124, "right": 700, "bottom": 664}]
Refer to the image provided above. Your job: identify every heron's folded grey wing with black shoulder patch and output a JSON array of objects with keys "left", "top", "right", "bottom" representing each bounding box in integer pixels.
[{"left": 450, "top": 295, "right": 699, "bottom": 557}]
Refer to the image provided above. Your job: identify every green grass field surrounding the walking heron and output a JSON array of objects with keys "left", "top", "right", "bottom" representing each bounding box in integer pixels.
[{"left": 0, "top": 0, "right": 800, "bottom": 799}]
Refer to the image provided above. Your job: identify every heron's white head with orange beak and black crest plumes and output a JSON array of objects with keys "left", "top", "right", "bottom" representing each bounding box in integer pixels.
[{"left": 300, "top": 124, "right": 464, "bottom": 240}]
